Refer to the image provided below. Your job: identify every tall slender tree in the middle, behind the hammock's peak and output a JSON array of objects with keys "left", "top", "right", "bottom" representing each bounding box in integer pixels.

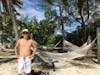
[{"left": 40, "top": 0, "right": 65, "bottom": 49}]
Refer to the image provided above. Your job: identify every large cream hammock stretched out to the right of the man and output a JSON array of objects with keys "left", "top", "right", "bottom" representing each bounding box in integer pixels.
[{"left": 34, "top": 38, "right": 96, "bottom": 63}]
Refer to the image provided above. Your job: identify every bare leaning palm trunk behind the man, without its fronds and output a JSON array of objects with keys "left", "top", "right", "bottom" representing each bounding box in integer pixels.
[{"left": 6, "top": 0, "right": 19, "bottom": 40}]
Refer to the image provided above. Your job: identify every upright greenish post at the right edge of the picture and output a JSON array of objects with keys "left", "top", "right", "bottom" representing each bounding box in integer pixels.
[{"left": 97, "top": 27, "right": 100, "bottom": 64}]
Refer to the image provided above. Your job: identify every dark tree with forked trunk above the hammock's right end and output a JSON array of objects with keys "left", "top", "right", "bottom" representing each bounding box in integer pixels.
[{"left": 77, "top": 0, "right": 98, "bottom": 43}]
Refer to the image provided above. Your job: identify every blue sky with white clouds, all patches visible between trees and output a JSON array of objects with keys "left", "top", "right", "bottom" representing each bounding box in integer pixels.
[{"left": 16, "top": 0, "right": 78, "bottom": 32}]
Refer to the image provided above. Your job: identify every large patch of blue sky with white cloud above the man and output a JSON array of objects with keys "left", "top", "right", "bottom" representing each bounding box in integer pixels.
[{"left": 16, "top": 0, "right": 44, "bottom": 20}]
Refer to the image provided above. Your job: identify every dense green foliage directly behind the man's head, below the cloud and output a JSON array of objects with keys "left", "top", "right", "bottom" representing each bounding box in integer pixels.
[{"left": 18, "top": 17, "right": 57, "bottom": 45}]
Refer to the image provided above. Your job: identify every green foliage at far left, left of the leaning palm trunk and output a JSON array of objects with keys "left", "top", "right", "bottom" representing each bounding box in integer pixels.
[{"left": 0, "top": 12, "right": 15, "bottom": 45}]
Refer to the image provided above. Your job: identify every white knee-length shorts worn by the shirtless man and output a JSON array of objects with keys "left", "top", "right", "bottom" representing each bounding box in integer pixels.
[{"left": 18, "top": 57, "right": 31, "bottom": 74}]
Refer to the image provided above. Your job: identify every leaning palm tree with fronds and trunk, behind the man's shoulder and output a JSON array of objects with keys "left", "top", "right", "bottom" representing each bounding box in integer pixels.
[{"left": 1, "top": 0, "right": 22, "bottom": 40}]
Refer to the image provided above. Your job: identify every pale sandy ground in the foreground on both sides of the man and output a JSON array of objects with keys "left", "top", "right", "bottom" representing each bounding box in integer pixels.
[{"left": 0, "top": 60, "right": 100, "bottom": 75}]
